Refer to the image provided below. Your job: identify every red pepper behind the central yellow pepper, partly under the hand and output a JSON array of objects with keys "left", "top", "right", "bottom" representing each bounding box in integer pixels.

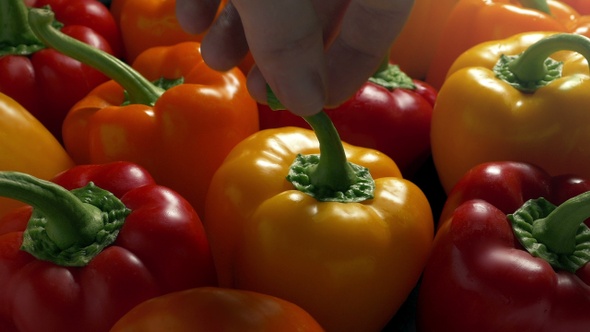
[{"left": 258, "top": 64, "right": 437, "bottom": 177}]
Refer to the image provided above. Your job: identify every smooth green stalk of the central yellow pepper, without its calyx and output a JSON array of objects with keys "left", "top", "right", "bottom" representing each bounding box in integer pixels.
[{"left": 303, "top": 111, "right": 356, "bottom": 191}]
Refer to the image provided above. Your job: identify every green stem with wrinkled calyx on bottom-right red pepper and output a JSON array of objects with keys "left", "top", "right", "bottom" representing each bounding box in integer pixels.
[{"left": 508, "top": 192, "right": 590, "bottom": 272}]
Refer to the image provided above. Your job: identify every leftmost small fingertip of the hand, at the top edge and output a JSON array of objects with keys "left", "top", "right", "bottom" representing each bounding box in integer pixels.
[{"left": 175, "top": 0, "right": 220, "bottom": 34}]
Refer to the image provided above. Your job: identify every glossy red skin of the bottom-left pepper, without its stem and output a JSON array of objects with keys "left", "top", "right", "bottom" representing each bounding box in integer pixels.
[{"left": 0, "top": 162, "right": 217, "bottom": 332}]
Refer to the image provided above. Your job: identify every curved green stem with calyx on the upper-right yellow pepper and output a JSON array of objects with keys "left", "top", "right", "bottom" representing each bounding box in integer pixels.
[{"left": 494, "top": 33, "right": 590, "bottom": 92}]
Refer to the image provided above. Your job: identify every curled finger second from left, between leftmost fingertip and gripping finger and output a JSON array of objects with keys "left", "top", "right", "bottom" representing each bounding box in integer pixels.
[{"left": 201, "top": 2, "right": 248, "bottom": 71}]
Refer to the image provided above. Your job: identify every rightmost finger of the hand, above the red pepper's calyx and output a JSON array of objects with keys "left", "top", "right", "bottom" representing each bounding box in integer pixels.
[{"left": 327, "top": 0, "right": 419, "bottom": 106}]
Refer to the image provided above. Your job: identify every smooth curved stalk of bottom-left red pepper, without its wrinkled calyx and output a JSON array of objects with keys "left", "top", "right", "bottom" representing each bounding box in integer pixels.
[{"left": 0, "top": 172, "right": 104, "bottom": 249}]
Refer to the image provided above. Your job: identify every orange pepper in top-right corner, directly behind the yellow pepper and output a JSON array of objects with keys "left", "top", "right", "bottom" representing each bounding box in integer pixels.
[{"left": 426, "top": 0, "right": 590, "bottom": 89}]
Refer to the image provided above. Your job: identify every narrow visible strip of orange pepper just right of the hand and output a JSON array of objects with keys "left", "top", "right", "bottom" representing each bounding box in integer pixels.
[{"left": 389, "top": 0, "right": 459, "bottom": 80}]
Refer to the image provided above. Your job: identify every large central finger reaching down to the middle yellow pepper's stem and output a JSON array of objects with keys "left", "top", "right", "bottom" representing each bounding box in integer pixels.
[{"left": 233, "top": 0, "right": 326, "bottom": 115}]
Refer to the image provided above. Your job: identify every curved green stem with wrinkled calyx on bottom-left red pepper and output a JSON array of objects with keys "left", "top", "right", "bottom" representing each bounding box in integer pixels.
[{"left": 0, "top": 172, "right": 129, "bottom": 266}]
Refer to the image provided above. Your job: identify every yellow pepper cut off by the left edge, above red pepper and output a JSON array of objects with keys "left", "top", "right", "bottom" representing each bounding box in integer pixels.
[{"left": 0, "top": 92, "right": 74, "bottom": 216}]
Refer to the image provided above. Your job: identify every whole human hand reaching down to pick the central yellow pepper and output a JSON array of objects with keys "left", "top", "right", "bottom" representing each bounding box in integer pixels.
[{"left": 176, "top": 0, "right": 413, "bottom": 116}]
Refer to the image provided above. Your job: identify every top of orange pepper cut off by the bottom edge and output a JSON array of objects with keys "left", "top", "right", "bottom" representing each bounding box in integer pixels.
[{"left": 110, "top": 287, "right": 324, "bottom": 332}]
